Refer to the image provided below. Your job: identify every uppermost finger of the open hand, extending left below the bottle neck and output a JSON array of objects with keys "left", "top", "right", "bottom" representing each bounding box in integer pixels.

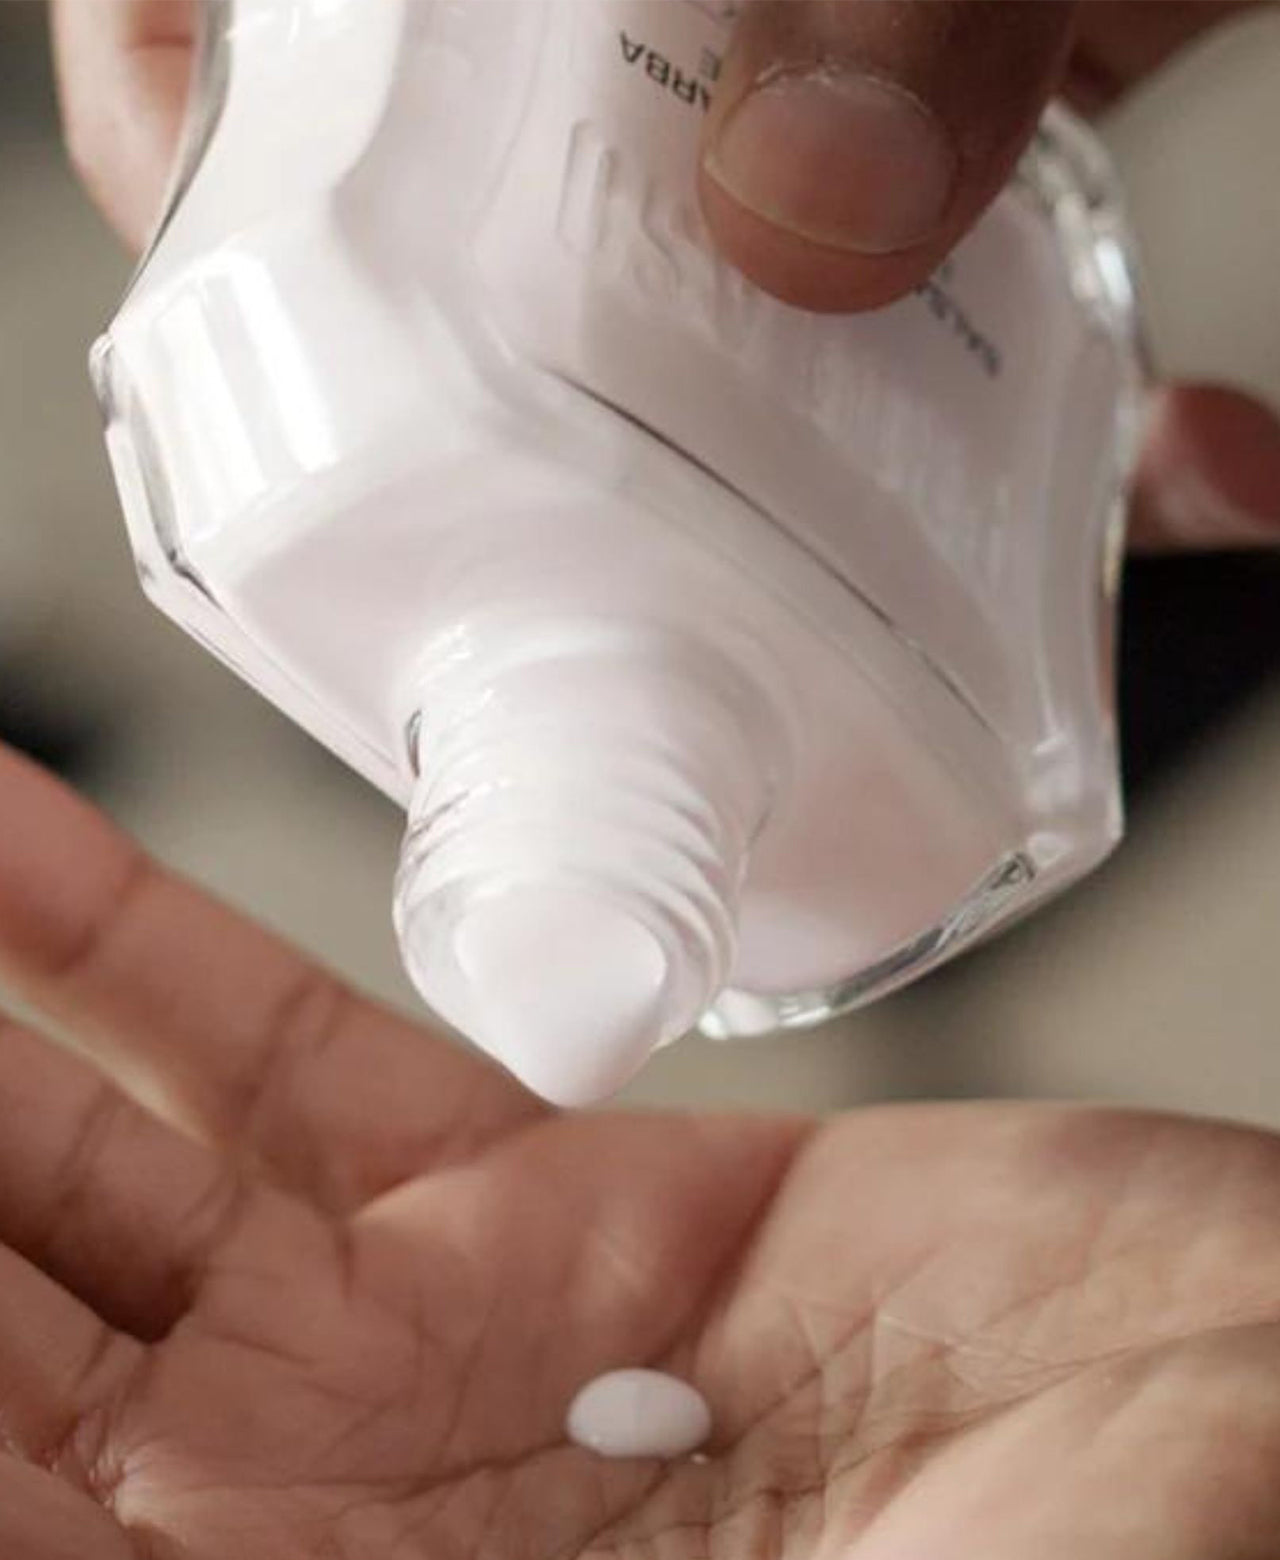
[{"left": 0, "top": 752, "right": 538, "bottom": 1212}]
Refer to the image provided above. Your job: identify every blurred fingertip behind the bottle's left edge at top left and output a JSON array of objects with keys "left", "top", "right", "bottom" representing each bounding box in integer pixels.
[{"left": 53, "top": 0, "right": 196, "bottom": 250}]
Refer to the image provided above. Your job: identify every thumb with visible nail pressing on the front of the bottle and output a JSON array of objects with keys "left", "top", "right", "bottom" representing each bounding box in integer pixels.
[{"left": 700, "top": 0, "right": 1074, "bottom": 310}]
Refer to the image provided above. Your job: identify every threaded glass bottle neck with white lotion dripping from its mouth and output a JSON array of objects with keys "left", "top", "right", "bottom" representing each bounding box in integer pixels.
[{"left": 396, "top": 621, "right": 780, "bottom": 1103}]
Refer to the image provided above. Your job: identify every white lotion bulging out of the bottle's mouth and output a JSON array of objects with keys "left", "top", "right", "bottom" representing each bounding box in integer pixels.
[{"left": 451, "top": 885, "right": 669, "bottom": 1106}]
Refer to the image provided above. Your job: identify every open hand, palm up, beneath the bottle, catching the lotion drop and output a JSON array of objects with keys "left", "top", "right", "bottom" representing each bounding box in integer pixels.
[{"left": 0, "top": 736, "right": 1280, "bottom": 1560}]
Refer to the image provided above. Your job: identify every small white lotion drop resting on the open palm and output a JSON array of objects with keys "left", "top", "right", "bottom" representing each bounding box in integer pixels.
[{"left": 566, "top": 1370, "right": 711, "bottom": 1457}]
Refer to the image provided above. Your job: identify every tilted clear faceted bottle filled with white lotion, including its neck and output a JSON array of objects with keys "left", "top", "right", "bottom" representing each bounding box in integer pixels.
[{"left": 94, "top": 0, "right": 1140, "bottom": 1103}]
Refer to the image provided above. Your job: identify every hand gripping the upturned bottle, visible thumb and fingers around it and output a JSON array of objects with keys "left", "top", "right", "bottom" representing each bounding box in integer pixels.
[{"left": 55, "top": 0, "right": 1280, "bottom": 546}]
